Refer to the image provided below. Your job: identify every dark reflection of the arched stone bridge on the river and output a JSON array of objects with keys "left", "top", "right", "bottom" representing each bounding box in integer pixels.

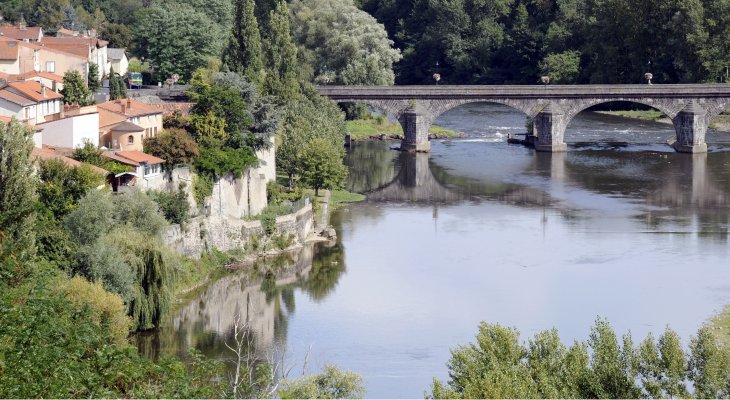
[{"left": 365, "top": 145, "right": 730, "bottom": 216}]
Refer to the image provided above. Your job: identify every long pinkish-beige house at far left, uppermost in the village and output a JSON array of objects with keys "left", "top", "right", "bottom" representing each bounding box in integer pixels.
[{"left": 0, "top": 37, "right": 88, "bottom": 77}]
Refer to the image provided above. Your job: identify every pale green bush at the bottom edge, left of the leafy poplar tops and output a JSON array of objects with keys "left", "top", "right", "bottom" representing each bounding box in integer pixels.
[{"left": 278, "top": 365, "right": 365, "bottom": 399}]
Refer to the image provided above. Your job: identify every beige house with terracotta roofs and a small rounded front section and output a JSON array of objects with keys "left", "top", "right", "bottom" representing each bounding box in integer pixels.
[{"left": 97, "top": 99, "right": 162, "bottom": 151}]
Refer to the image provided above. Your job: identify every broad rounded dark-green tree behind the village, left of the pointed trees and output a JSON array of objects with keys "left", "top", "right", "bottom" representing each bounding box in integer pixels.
[{"left": 133, "top": 2, "right": 225, "bottom": 82}]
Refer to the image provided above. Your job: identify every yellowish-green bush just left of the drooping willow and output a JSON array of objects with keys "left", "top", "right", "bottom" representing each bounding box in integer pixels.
[{"left": 59, "top": 276, "right": 132, "bottom": 344}]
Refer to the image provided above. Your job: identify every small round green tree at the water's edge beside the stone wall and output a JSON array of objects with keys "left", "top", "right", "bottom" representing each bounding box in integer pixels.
[{"left": 300, "top": 138, "right": 347, "bottom": 196}]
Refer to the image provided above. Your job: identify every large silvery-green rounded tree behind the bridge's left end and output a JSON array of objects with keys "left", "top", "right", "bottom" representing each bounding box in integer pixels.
[{"left": 290, "top": 0, "right": 401, "bottom": 85}]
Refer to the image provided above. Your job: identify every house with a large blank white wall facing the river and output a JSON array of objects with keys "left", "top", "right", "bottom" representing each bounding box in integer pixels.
[{"left": 36, "top": 106, "right": 99, "bottom": 149}]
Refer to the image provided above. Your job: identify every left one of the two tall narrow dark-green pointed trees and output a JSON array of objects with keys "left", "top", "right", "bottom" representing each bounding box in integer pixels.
[{"left": 223, "top": 0, "right": 264, "bottom": 86}]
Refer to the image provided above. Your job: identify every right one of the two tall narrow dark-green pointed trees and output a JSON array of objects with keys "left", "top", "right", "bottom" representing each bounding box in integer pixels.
[{"left": 264, "top": 0, "right": 299, "bottom": 104}]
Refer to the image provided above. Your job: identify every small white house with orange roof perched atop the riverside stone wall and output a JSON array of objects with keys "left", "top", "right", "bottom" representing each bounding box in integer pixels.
[{"left": 103, "top": 150, "right": 165, "bottom": 192}]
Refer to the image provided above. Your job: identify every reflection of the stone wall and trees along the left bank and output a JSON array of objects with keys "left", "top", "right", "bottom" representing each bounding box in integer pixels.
[{"left": 140, "top": 238, "right": 345, "bottom": 359}]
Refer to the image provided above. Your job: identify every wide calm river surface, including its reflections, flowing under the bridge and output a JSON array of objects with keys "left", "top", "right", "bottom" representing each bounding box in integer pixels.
[{"left": 140, "top": 104, "right": 730, "bottom": 398}]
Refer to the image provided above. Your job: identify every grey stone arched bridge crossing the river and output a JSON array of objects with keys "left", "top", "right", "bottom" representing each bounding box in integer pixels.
[{"left": 317, "top": 84, "right": 730, "bottom": 153}]
